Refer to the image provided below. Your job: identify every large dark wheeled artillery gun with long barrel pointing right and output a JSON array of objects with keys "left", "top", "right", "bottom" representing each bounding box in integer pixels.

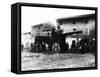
[{"left": 33, "top": 22, "right": 82, "bottom": 53}]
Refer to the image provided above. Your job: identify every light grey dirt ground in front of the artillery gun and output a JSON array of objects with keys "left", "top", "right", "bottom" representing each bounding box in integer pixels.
[{"left": 21, "top": 52, "right": 95, "bottom": 71}]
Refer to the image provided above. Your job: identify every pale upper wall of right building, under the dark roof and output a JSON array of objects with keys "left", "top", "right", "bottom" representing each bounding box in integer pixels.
[{"left": 61, "top": 19, "right": 95, "bottom": 35}]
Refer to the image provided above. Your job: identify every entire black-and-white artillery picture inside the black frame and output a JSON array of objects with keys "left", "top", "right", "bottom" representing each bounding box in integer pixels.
[{"left": 21, "top": 6, "right": 96, "bottom": 71}]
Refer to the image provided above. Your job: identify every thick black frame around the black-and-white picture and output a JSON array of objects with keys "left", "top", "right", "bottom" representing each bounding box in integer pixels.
[{"left": 11, "top": 2, "right": 98, "bottom": 74}]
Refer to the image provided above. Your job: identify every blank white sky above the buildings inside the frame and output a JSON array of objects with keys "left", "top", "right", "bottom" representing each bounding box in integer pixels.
[{"left": 21, "top": 6, "right": 95, "bottom": 33}]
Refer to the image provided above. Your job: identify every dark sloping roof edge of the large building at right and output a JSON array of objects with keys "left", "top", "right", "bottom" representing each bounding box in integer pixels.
[{"left": 57, "top": 14, "right": 96, "bottom": 24}]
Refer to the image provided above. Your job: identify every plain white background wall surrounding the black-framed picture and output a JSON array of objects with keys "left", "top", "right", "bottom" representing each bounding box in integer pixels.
[{"left": 0, "top": 0, "right": 100, "bottom": 77}]
